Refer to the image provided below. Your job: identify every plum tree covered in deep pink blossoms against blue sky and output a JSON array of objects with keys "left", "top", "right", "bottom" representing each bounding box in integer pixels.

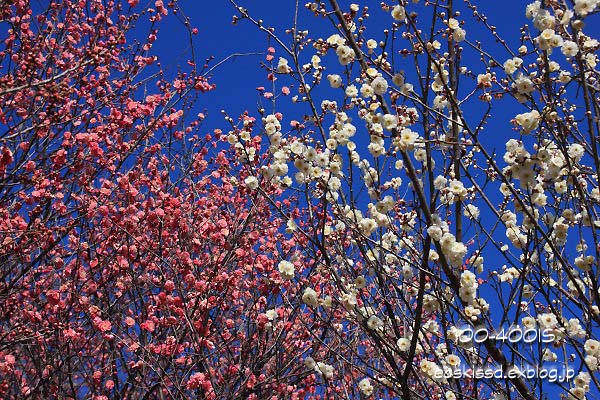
[{"left": 0, "top": 0, "right": 322, "bottom": 400}]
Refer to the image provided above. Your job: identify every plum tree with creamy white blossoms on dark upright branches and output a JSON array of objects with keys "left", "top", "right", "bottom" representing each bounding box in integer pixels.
[{"left": 221, "top": 0, "right": 600, "bottom": 400}]
